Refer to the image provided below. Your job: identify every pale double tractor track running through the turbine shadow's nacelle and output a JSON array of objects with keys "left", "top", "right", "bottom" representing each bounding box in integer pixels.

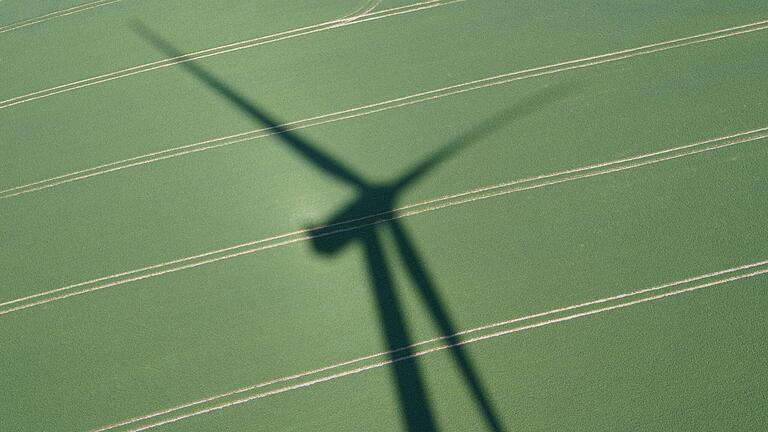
[{"left": 0, "top": 127, "right": 768, "bottom": 316}]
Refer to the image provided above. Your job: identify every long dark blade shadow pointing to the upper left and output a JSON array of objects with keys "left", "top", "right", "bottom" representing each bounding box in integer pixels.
[{"left": 134, "top": 23, "right": 366, "bottom": 187}]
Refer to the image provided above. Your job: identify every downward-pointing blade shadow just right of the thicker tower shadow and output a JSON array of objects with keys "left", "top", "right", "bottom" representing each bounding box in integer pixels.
[{"left": 389, "top": 220, "right": 504, "bottom": 432}]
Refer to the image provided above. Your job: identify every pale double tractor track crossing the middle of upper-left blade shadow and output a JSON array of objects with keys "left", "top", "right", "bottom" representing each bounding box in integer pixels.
[{"left": 0, "top": 16, "right": 768, "bottom": 200}]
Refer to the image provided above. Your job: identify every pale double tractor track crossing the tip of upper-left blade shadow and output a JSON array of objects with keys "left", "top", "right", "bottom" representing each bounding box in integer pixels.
[{"left": 0, "top": 0, "right": 466, "bottom": 109}]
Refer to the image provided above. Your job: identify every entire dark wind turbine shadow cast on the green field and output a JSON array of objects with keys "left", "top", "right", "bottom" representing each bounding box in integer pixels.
[{"left": 135, "top": 24, "right": 570, "bottom": 432}]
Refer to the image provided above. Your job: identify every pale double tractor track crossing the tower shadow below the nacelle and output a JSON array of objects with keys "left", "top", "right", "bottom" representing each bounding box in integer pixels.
[{"left": 91, "top": 260, "right": 768, "bottom": 432}]
